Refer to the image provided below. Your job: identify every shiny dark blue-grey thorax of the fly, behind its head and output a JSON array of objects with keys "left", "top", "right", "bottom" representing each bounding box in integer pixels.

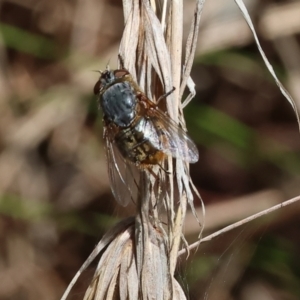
[{"left": 99, "top": 81, "right": 137, "bottom": 128}]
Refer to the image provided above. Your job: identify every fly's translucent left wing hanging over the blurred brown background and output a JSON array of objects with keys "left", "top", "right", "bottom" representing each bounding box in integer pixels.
[{"left": 104, "top": 128, "right": 139, "bottom": 206}]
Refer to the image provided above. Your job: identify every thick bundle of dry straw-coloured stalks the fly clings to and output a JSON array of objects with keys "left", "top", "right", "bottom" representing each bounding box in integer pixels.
[{"left": 62, "top": 0, "right": 203, "bottom": 300}]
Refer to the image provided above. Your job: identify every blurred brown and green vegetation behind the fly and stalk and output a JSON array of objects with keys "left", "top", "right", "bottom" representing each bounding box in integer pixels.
[{"left": 0, "top": 0, "right": 300, "bottom": 300}]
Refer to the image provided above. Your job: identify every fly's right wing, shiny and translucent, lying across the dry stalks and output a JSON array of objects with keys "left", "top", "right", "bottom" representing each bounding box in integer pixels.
[{"left": 148, "top": 107, "right": 199, "bottom": 163}]
